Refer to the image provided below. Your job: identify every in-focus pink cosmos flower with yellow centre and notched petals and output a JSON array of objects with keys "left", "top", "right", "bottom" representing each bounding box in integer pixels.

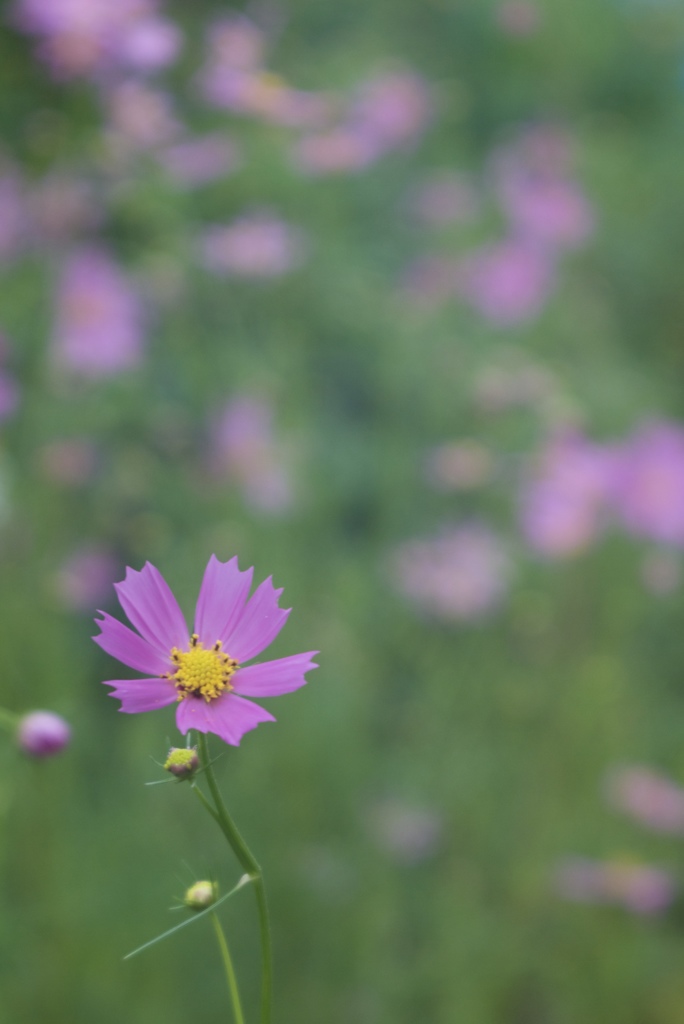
[{"left": 93, "top": 555, "right": 317, "bottom": 746}]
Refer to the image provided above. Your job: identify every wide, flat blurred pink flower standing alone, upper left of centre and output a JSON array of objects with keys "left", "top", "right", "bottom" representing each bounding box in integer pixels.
[{"left": 200, "top": 211, "right": 306, "bottom": 278}]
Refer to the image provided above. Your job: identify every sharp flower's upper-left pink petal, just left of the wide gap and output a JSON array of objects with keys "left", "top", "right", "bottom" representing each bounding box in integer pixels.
[{"left": 114, "top": 562, "right": 189, "bottom": 655}]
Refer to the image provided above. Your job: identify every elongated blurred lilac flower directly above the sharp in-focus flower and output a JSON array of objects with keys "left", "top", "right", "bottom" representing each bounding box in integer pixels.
[{"left": 212, "top": 395, "right": 294, "bottom": 513}]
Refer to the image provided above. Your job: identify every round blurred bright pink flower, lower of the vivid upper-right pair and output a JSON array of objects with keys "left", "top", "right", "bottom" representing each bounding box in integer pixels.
[{"left": 461, "top": 239, "right": 555, "bottom": 328}]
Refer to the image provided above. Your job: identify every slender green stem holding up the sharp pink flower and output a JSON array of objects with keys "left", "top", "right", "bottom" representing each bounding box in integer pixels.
[{"left": 196, "top": 733, "right": 273, "bottom": 1024}]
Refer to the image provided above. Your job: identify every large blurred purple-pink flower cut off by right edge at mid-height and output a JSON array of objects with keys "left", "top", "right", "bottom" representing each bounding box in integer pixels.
[{"left": 613, "top": 420, "right": 684, "bottom": 547}]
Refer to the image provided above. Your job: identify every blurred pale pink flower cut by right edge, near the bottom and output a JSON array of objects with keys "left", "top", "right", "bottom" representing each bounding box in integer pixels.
[{"left": 605, "top": 765, "right": 684, "bottom": 834}]
